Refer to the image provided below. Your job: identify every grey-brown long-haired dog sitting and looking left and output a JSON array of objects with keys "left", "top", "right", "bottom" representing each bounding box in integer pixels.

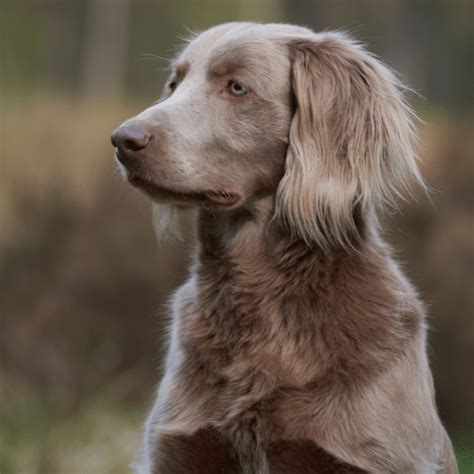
[{"left": 112, "top": 23, "right": 457, "bottom": 474}]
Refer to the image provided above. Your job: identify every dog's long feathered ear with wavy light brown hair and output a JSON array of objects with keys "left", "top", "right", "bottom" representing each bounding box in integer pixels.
[{"left": 276, "top": 33, "right": 423, "bottom": 250}]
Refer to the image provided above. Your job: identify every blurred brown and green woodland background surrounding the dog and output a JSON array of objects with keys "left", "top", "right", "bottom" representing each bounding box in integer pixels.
[{"left": 0, "top": 0, "right": 474, "bottom": 474}]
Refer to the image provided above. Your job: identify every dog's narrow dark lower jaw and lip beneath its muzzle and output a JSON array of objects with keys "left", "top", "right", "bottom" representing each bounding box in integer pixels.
[{"left": 127, "top": 173, "right": 241, "bottom": 209}]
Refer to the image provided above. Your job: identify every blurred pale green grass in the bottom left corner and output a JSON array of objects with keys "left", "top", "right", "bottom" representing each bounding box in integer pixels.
[{"left": 0, "top": 380, "right": 145, "bottom": 474}]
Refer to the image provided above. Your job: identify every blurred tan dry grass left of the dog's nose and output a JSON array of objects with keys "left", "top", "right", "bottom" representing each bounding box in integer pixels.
[{"left": 0, "top": 99, "right": 137, "bottom": 240}]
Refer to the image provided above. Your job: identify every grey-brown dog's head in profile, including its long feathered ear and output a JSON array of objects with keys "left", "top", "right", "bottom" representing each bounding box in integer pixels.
[{"left": 112, "top": 23, "right": 421, "bottom": 249}]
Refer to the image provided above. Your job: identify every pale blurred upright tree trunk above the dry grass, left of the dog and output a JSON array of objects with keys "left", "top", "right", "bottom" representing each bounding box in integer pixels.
[{"left": 82, "top": 0, "right": 130, "bottom": 97}]
